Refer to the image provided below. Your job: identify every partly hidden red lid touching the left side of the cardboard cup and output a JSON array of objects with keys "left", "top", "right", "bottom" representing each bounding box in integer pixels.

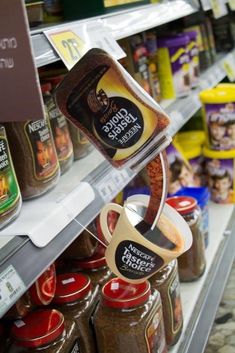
[{"left": 73, "top": 244, "right": 107, "bottom": 270}]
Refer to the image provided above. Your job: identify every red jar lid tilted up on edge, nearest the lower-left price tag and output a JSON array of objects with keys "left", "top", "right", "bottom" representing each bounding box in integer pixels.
[{"left": 29, "top": 264, "right": 56, "bottom": 305}]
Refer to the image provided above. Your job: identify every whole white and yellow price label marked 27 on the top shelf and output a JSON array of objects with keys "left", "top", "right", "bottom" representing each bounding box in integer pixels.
[{"left": 44, "top": 20, "right": 126, "bottom": 70}]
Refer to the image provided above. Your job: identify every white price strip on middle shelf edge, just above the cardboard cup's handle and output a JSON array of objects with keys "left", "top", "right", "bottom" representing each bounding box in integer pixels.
[{"left": 96, "top": 170, "right": 130, "bottom": 202}]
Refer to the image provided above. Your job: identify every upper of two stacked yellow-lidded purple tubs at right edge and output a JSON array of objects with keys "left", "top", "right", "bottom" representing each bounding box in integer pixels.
[{"left": 199, "top": 86, "right": 235, "bottom": 151}]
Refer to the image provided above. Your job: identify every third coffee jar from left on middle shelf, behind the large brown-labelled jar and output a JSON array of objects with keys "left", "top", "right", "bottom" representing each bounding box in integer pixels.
[{"left": 41, "top": 83, "right": 73, "bottom": 174}]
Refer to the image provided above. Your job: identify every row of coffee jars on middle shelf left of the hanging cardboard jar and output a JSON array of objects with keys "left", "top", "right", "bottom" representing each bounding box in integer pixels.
[{"left": 0, "top": 77, "right": 91, "bottom": 228}]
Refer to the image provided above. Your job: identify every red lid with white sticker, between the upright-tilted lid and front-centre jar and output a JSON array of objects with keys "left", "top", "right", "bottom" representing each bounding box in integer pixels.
[{"left": 54, "top": 272, "right": 91, "bottom": 304}]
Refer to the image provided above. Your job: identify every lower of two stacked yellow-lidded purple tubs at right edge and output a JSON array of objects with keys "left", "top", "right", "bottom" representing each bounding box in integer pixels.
[{"left": 203, "top": 147, "right": 235, "bottom": 204}]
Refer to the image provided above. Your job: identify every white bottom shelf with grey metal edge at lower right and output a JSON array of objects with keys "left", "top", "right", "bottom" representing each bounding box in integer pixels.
[{"left": 170, "top": 204, "right": 235, "bottom": 353}]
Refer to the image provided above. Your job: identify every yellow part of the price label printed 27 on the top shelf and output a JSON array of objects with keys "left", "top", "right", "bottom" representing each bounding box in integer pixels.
[{"left": 47, "top": 30, "right": 87, "bottom": 70}]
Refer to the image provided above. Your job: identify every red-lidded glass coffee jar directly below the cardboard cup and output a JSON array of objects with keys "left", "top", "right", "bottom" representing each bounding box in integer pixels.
[{"left": 94, "top": 278, "right": 167, "bottom": 353}]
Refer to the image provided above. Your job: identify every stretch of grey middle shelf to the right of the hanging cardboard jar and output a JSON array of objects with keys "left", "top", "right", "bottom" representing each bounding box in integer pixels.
[{"left": 161, "top": 50, "right": 235, "bottom": 136}]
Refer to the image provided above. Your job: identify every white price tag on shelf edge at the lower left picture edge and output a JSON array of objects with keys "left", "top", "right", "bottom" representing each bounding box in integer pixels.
[{"left": 0, "top": 265, "right": 26, "bottom": 317}]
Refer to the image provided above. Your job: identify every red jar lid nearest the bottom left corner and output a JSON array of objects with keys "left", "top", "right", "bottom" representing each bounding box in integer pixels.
[{"left": 11, "top": 310, "right": 64, "bottom": 348}]
